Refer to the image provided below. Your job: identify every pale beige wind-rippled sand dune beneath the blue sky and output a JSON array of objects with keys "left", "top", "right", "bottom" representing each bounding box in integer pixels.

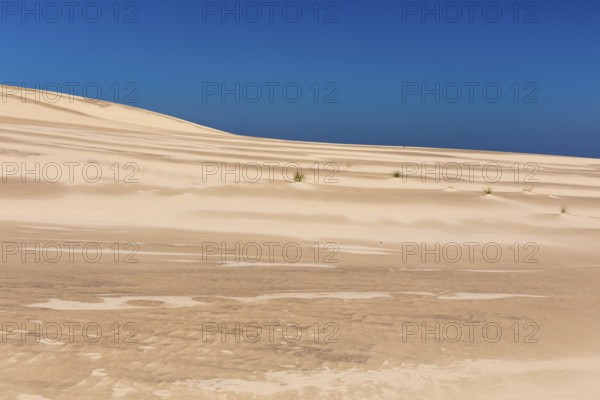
[{"left": 0, "top": 88, "right": 600, "bottom": 400}]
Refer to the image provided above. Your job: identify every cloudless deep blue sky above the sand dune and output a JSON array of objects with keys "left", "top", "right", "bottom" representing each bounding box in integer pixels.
[{"left": 0, "top": 0, "right": 600, "bottom": 157}]
